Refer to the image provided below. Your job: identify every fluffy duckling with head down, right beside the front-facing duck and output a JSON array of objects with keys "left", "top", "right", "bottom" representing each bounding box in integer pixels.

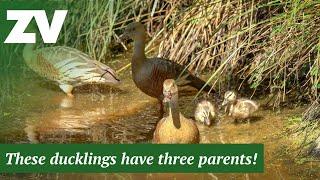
[{"left": 194, "top": 100, "right": 217, "bottom": 126}]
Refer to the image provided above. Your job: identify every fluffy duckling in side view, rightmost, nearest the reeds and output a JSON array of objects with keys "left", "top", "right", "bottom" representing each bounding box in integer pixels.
[{"left": 222, "top": 91, "right": 259, "bottom": 122}]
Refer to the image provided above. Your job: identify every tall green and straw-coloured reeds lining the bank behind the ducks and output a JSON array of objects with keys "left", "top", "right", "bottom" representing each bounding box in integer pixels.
[{"left": 1, "top": 0, "right": 320, "bottom": 107}]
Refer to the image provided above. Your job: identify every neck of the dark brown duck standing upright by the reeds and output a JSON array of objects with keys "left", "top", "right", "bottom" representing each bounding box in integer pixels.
[{"left": 132, "top": 34, "right": 146, "bottom": 69}]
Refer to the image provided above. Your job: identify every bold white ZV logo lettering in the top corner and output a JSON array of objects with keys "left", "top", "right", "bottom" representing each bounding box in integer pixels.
[{"left": 4, "top": 10, "right": 68, "bottom": 43}]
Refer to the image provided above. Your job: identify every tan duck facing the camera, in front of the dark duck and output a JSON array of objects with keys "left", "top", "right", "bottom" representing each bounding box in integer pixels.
[{"left": 153, "top": 79, "right": 200, "bottom": 144}]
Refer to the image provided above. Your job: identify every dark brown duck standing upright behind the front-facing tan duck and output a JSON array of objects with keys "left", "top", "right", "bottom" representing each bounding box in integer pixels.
[{"left": 121, "top": 22, "right": 214, "bottom": 118}]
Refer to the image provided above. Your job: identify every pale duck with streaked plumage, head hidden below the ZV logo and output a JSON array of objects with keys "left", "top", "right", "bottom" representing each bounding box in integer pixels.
[{"left": 23, "top": 44, "right": 120, "bottom": 97}]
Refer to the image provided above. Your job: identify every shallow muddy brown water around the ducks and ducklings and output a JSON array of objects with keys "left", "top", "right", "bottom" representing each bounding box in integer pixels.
[{"left": 0, "top": 58, "right": 320, "bottom": 179}]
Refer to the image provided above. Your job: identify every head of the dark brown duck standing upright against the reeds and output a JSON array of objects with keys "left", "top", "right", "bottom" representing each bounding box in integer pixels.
[{"left": 121, "top": 22, "right": 145, "bottom": 40}]
